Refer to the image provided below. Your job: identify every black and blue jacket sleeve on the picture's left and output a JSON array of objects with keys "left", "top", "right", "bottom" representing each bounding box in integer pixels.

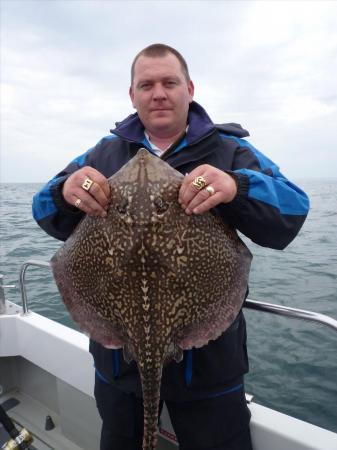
[{"left": 32, "top": 149, "right": 92, "bottom": 241}]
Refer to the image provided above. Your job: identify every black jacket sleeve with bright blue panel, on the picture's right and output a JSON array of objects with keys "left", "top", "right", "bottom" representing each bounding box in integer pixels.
[{"left": 219, "top": 136, "right": 309, "bottom": 250}]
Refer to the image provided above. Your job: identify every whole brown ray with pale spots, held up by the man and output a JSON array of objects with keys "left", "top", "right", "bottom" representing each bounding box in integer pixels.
[{"left": 51, "top": 149, "right": 251, "bottom": 450}]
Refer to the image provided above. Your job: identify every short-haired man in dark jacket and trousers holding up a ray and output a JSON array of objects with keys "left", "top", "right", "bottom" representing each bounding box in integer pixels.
[{"left": 33, "top": 44, "right": 309, "bottom": 450}]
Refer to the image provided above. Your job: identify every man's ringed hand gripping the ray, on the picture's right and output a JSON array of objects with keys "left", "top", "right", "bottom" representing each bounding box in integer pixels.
[{"left": 178, "top": 164, "right": 237, "bottom": 214}]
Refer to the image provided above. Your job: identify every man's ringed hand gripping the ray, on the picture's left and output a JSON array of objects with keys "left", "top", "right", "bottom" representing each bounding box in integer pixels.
[{"left": 62, "top": 166, "right": 110, "bottom": 217}]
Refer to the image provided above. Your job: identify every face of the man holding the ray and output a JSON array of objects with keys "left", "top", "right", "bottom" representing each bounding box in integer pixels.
[{"left": 130, "top": 53, "right": 194, "bottom": 138}]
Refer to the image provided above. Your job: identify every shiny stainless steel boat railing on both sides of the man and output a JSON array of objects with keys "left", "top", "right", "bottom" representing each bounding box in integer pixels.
[{"left": 0, "top": 259, "right": 337, "bottom": 331}]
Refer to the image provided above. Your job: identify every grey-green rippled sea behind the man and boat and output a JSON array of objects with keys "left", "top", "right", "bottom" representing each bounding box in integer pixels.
[{"left": 0, "top": 179, "right": 337, "bottom": 432}]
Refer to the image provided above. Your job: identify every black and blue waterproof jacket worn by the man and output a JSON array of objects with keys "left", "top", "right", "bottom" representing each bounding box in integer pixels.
[{"left": 33, "top": 102, "right": 309, "bottom": 401}]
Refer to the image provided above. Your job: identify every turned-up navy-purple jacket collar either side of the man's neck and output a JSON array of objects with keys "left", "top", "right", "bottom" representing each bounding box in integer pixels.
[{"left": 110, "top": 101, "right": 215, "bottom": 144}]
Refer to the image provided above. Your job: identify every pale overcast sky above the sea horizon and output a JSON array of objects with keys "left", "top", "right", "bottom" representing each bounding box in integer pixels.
[{"left": 1, "top": 0, "right": 337, "bottom": 182}]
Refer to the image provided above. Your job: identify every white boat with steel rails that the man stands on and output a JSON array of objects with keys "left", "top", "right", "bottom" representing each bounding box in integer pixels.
[{"left": 0, "top": 260, "right": 337, "bottom": 450}]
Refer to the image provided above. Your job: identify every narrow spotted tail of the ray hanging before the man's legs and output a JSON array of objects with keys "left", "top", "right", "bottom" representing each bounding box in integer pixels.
[{"left": 140, "top": 369, "right": 162, "bottom": 450}]
